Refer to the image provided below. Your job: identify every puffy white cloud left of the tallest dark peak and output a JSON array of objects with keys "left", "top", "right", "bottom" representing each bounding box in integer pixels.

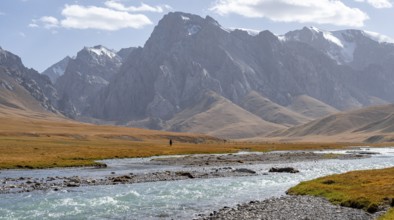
[{"left": 60, "top": 5, "right": 152, "bottom": 31}]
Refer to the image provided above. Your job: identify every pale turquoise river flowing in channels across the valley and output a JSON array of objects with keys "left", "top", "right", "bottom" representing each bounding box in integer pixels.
[{"left": 0, "top": 148, "right": 394, "bottom": 219}]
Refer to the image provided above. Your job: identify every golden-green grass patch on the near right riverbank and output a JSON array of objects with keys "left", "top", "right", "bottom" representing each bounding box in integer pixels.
[{"left": 288, "top": 167, "right": 394, "bottom": 217}]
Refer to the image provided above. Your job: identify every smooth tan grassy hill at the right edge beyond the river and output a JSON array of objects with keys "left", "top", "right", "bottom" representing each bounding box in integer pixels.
[{"left": 270, "top": 104, "right": 394, "bottom": 142}]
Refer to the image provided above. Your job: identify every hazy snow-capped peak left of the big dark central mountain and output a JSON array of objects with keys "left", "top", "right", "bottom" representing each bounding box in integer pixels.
[{"left": 55, "top": 46, "right": 122, "bottom": 115}]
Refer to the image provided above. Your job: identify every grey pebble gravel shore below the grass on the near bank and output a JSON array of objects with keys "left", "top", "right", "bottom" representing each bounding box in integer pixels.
[{"left": 198, "top": 196, "right": 382, "bottom": 220}]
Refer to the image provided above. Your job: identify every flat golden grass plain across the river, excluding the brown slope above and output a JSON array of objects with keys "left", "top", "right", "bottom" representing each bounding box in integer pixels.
[{"left": 0, "top": 131, "right": 378, "bottom": 169}]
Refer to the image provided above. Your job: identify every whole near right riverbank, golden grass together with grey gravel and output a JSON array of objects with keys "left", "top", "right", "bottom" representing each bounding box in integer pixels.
[{"left": 200, "top": 167, "right": 394, "bottom": 220}]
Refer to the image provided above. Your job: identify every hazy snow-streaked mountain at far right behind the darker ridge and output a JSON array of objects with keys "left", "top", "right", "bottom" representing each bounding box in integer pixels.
[{"left": 282, "top": 27, "right": 394, "bottom": 102}]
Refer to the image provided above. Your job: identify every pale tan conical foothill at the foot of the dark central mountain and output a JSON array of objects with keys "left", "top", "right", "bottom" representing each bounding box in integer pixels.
[{"left": 167, "top": 92, "right": 283, "bottom": 138}]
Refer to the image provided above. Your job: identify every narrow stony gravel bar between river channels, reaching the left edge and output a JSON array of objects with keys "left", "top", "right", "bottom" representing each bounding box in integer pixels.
[{"left": 0, "top": 167, "right": 258, "bottom": 194}]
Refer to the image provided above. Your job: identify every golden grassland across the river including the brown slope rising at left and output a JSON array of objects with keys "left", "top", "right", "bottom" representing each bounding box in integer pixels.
[{"left": 0, "top": 105, "right": 390, "bottom": 169}]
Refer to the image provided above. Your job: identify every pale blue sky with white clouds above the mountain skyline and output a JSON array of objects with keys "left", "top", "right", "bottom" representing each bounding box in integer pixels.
[{"left": 0, "top": 0, "right": 394, "bottom": 72}]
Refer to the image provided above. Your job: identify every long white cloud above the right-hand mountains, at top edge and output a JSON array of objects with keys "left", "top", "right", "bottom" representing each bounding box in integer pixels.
[{"left": 210, "top": 0, "right": 370, "bottom": 27}]
